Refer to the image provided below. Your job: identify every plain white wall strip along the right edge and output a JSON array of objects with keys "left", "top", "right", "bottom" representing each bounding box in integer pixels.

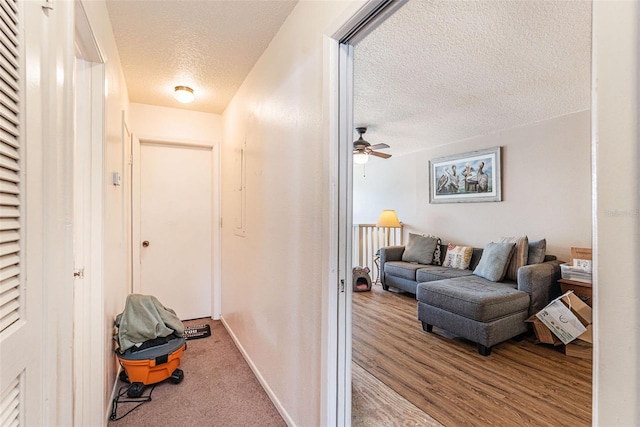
[{"left": 593, "top": 1, "right": 640, "bottom": 426}]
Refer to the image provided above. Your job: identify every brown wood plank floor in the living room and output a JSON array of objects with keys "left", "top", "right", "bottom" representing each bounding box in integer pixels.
[{"left": 352, "top": 285, "right": 591, "bottom": 426}]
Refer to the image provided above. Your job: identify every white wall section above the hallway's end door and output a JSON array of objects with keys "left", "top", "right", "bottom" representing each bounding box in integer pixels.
[{"left": 129, "top": 103, "right": 222, "bottom": 145}]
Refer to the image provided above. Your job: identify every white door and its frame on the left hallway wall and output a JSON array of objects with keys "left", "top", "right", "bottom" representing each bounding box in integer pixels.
[{"left": 72, "top": 2, "right": 111, "bottom": 425}]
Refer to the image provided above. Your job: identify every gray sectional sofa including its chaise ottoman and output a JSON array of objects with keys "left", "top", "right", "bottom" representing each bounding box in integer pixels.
[{"left": 380, "top": 235, "right": 562, "bottom": 356}]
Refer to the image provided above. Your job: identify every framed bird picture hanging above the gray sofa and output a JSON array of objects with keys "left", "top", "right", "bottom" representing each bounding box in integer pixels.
[{"left": 429, "top": 147, "right": 502, "bottom": 203}]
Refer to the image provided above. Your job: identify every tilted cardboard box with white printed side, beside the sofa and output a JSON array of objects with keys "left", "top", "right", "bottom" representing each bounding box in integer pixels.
[{"left": 534, "top": 291, "right": 593, "bottom": 344}]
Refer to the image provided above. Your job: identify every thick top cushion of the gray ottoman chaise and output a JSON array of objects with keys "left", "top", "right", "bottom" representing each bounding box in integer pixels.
[{"left": 416, "top": 276, "right": 529, "bottom": 322}]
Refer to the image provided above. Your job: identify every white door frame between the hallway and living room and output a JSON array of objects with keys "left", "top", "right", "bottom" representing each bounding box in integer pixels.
[{"left": 322, "top": 0, "right": 407, "bottom": 426}]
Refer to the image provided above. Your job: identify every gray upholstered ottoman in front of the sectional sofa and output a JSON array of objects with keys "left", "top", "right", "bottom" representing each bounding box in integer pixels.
[{"left": 416, "top": 276, "right": 530, "bottom": 356}]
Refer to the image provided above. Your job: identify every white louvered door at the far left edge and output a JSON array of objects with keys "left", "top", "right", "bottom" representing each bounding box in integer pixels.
[{"left": 0, "top": 2, "right": 43, "bottom": 426}]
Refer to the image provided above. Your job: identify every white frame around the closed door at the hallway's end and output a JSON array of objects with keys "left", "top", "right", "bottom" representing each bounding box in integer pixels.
[{"left": 131, "top": 133, "right": 222, "bottom": 320}]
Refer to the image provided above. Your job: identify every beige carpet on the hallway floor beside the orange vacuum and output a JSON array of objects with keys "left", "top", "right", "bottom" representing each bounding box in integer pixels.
[{"left": 109, "top": 319, "right": 286, "bottom": 427}]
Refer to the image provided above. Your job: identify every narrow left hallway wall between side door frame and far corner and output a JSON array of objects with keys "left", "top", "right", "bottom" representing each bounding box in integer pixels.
[{"left": 79, "top": 0, "right": 129, "bottom": 414}]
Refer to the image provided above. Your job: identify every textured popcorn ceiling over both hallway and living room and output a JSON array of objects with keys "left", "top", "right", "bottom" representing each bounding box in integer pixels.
[{"left": 107, "top": 0, "right": 591, "bottom": 157}]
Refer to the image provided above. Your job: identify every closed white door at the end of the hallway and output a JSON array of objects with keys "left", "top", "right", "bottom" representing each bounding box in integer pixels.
[{"left": 134, "top": 142, "right": 212, "bottom": 320}]
